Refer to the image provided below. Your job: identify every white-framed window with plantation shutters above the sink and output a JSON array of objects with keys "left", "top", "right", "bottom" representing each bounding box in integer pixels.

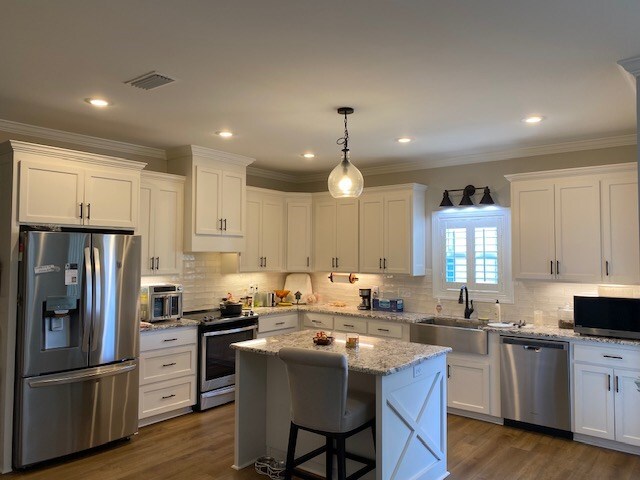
[{"left": 432, "top": 207, "right": 513, "bottom": 303}]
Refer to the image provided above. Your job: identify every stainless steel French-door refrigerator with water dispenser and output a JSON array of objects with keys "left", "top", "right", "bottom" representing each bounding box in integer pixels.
[{"left": 13, "top": 231, "right": 140, "bottom": 468}]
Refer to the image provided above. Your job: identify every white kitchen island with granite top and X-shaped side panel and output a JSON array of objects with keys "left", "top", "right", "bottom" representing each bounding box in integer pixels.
[{"left": 232, "top": 330, "right": 451, "bottom": 480}]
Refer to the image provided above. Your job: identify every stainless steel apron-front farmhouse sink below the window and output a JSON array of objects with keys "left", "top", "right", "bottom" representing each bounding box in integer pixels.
[{"left": 410, "top": 317, "right": 489, "bottom": 355}]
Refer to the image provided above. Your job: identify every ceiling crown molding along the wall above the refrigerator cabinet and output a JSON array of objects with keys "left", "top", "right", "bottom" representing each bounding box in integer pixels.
[{"left": 0, "top": 119, "right": 166, "bottom": 160}]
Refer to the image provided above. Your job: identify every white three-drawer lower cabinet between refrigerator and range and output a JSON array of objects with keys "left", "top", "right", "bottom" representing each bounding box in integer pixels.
[{"left": 138, "top": 326, "right": 198, "bottom": 426}]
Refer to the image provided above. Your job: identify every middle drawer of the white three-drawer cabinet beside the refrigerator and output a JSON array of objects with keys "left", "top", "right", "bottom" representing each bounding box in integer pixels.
[{"left": 140, "top": 345, "right": 197, "bottom": 385}]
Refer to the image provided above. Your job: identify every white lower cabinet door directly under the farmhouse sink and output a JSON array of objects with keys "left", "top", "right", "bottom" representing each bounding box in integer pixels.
[{"left": 447, "top": 353, "right": 491, "bottom": 415}]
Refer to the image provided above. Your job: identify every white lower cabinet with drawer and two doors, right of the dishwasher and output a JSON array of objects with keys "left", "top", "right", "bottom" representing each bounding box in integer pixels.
[{"left": 573, "top": 345, "right": 640, "bottom": 446}]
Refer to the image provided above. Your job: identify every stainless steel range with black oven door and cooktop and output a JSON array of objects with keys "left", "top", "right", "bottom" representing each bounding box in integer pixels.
[{"left": 183, "top": 310, "right": 258, "bottom": 410}]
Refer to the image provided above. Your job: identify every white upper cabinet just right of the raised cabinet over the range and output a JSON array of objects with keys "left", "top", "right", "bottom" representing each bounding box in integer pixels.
[{"left": 240, "top": 187, "right": 284, "bottom": 272}]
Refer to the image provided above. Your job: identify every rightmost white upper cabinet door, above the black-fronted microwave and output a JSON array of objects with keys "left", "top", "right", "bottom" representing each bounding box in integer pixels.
[{"left": 601, "top": 172, "right": 640, "bottom": 283}]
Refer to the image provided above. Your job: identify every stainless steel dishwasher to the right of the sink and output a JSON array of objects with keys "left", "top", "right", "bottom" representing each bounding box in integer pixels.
[{"left": 500, "top": 336, "right": 571, "bottom": 432}]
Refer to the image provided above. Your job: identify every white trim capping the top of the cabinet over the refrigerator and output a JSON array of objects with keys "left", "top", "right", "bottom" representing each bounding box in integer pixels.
[{"left": 0, "top": 140, "right": 147, "bottom": 170}]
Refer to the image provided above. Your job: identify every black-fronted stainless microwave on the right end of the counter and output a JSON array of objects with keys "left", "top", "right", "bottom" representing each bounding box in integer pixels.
[{"left": 573, "top": 296, "right": 640, "bottom": 339}]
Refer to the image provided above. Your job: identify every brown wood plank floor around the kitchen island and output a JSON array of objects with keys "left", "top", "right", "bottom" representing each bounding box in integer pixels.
[{"left": 2, "top": 404, "right": 640, "bottom": 480}]
